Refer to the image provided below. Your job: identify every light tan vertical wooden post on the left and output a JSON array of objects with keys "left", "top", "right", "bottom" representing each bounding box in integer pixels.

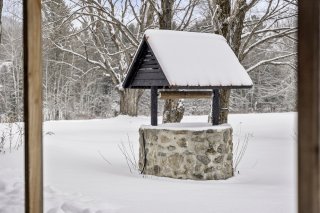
[{"left": 23, "top": 0, "right": 43, "bottom": 213}]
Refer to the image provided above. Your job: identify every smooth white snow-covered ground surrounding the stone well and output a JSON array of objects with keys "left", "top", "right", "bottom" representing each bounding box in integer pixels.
[{"left": 0, "top": 113, "right": 297, "bottom": 213}]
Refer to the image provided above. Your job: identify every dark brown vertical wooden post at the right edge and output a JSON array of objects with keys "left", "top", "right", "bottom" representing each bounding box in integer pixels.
[{"left": 298, "top": 0, "right": 320, "bottom": 213}]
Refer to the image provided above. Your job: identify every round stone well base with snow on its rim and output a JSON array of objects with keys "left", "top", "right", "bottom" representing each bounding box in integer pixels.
[{"left": 139, "top": 123, "right": 233, "bottom": 180}]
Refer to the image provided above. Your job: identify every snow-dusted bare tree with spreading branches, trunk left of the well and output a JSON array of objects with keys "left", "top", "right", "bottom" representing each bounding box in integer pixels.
[{"left": 49, "top": 0, "right": 195, "bottom": 116}]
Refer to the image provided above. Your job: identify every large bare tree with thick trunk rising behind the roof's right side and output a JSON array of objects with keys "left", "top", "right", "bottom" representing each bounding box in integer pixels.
[{"left": 203, "top": 0, "right": 297, "bottom": 123}]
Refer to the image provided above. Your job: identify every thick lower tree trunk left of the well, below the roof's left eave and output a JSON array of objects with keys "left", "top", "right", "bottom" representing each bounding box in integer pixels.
[{"left": 118, "top": 89, "right": 143, "bottom": 116}]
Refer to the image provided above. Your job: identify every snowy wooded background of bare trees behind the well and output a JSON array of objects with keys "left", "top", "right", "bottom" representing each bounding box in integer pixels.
[{"left": 0, "top": 0, "right": 297, "bottom": 122}]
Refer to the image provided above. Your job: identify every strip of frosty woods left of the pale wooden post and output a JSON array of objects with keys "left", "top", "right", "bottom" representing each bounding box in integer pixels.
[{"left": 0, "top": 2, "right": 23, "bottom": 122}]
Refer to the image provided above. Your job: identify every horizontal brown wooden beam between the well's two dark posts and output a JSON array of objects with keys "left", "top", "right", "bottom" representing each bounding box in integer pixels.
[{"left": 160, "top": 91, "right": 212, "bottom": 99}]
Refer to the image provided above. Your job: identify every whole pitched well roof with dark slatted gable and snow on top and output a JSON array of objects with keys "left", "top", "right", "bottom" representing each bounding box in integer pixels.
[{"left": 123, "top": 30, "right": 252, "bottom": 88}]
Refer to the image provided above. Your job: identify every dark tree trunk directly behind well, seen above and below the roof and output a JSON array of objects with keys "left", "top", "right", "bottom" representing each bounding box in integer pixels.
[{"left": 159, "top": 0, "right": 184, "bottom": 123}]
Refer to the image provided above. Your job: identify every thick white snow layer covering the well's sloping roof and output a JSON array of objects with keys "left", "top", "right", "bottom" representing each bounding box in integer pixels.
[{"left": 122, "top": 30, "right": 252, "bottom": 87}]
